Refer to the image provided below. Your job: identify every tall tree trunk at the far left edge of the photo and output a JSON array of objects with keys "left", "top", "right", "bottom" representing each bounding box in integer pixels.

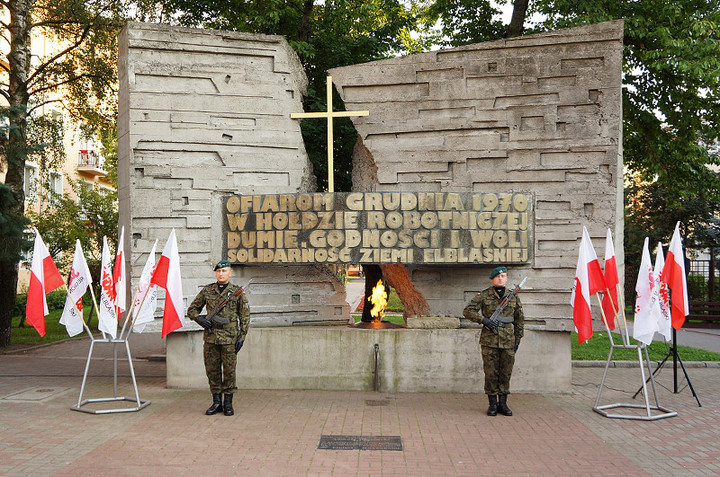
[{"left": 0, "top": 0, "right": 32, "bottom": 347}]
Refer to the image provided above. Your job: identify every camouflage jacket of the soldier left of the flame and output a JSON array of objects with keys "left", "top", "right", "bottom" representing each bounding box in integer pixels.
[{"left": 187, "top": 283, "right": 250, "bottom": 344}]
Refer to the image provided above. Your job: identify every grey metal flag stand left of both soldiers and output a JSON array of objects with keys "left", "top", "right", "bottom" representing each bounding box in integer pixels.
[{"left": 70, "top": 308, "right": 150, "bottom": 414}]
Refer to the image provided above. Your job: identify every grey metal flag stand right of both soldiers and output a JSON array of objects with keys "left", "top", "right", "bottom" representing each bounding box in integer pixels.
[{"left": 593, "top": 324, "right": 677, "bottom": 421}]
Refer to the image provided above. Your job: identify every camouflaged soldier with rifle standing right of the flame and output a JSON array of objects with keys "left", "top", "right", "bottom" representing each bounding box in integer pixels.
[{"left": 463, "top": 267, "right": 525, "bottom": 416}]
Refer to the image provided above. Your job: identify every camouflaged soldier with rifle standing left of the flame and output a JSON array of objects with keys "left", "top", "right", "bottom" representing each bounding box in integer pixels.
[{"left": 187, "top": 260, "right": 250, "bottom": 416}]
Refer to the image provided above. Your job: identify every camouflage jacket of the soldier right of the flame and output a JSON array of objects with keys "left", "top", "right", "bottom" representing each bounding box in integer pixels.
[{"left": 463, "top": 287, "right": 525, "bottom": 348}]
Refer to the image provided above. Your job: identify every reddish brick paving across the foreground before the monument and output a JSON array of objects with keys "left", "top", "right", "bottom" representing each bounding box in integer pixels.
[{"left": 0, "top": 337, "right": 720, "bottom": 477}]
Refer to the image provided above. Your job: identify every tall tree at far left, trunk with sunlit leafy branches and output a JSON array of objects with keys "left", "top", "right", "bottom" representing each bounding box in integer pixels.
[{"left": 0, "top": 0, "right": 122, "bottom": 347}]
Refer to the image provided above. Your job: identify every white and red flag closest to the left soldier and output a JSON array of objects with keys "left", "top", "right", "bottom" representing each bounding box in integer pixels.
[{"left": 150, "top": 229, "right": 185, "bottom": 338}]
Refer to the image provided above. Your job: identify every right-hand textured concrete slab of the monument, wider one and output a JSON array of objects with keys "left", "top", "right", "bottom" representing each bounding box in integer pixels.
[{"left": 330, "top": 21, "right": 623, "bottom": 330}]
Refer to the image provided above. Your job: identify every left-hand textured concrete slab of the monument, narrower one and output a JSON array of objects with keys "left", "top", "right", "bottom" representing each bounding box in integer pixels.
[{"left": 118, "top": 23, "right": 349, "bottom": 325}]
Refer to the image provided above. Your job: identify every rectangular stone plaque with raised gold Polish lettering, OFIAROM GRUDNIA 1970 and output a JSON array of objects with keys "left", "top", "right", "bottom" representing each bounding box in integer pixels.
[{"left": 223, "top": 192, "right": 533, "bottom": 264}]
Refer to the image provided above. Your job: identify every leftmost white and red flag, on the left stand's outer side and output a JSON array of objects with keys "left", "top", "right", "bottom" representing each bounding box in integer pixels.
[{"left": 25, "top": 229, "right": 65, "bottom": 336}]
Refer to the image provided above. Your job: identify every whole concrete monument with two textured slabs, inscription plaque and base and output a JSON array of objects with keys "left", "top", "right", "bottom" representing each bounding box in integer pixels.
[{"left": 118, "top": 21, "right": 623, "bottom": 392}]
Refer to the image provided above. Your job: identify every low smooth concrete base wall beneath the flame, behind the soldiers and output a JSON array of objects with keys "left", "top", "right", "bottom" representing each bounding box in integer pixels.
[{"left": 167, "top": 326, "right": 572, "bottom": 393}]
